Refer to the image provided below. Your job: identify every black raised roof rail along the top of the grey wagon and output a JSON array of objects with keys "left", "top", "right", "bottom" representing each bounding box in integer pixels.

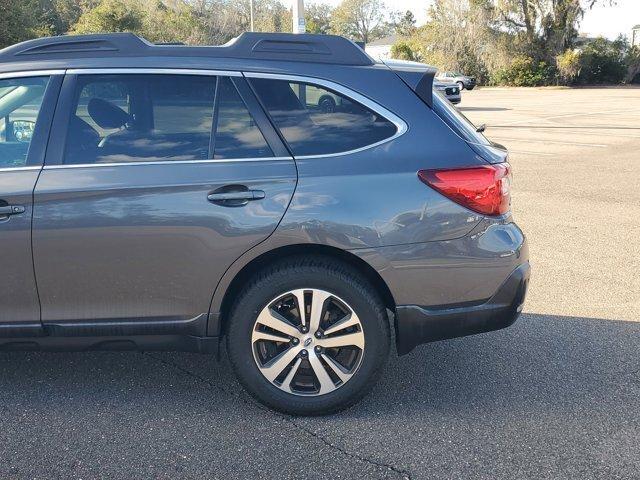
[{"left": 0, "top": 32, "right": 375, "bottom": 66}]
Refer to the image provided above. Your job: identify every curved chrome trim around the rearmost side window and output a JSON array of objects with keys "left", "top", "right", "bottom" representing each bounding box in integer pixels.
[{"left": 243, "top": 72, "right": 409, "bottom": 160}]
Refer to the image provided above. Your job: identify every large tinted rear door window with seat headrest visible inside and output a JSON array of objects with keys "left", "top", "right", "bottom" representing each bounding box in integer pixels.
[{"left": 65, "top": 75, "right": 216, "bottom": 164}]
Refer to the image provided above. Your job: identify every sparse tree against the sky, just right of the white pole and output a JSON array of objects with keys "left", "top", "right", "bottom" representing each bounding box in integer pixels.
[{"left": 331, "top": 0, "right": 390, "bottom": 43}]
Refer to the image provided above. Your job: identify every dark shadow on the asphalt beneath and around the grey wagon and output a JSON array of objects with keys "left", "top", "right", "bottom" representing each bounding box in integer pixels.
[{"left": 0, "top": 314, "right": 640, "bottom": 479}]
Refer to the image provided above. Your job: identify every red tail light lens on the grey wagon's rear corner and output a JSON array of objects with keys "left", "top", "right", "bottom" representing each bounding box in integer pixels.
[{"left": 418, "top": 163, "right": 511, "bottom": 215}]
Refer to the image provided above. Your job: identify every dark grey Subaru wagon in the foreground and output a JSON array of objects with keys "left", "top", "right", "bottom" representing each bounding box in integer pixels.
[{"left": 0, "top": 33, "right": 529, "bottom": 414}]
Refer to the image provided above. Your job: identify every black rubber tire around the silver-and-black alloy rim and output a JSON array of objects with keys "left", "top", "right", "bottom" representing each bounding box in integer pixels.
[{"left": 227, "top": 256, "right": 390, "bottom": 415}]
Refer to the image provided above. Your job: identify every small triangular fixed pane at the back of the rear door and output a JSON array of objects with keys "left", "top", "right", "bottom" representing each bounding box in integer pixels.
[{"left": 214, "top": 78, "right": 273, "bottom": 158}]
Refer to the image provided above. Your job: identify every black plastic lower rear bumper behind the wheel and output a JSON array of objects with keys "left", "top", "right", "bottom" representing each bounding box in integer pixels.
[{"left": 396, "top": 261, "right": 531, "bottom": 355}]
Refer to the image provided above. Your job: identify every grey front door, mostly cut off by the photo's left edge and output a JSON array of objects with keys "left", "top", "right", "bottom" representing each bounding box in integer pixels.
[{"left": 0, "top": 72, "right": 60, "bottom": 337}]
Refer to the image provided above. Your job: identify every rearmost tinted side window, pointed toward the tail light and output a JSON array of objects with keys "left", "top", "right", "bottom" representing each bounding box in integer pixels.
[{"left": 251, "top": 79, "right": 397, "bottom": 156}]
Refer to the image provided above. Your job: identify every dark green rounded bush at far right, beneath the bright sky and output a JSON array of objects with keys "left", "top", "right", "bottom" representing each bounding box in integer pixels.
[{"left": 578, "top": 38, "right": 629, "bottom": 84}]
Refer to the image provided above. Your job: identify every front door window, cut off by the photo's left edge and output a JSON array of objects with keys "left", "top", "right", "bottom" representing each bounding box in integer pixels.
[{"left": 0, "top": 77, "right": 49, "bottom": 168}]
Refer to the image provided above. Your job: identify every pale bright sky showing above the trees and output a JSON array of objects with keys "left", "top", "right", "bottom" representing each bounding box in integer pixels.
[{"left": 305, "top": 0, "right": 640, "bottom": 40}]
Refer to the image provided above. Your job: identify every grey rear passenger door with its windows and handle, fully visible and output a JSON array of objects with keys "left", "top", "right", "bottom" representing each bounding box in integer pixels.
[{"left": 33, "top": 70, "right": 297, "bottom": 335}]
